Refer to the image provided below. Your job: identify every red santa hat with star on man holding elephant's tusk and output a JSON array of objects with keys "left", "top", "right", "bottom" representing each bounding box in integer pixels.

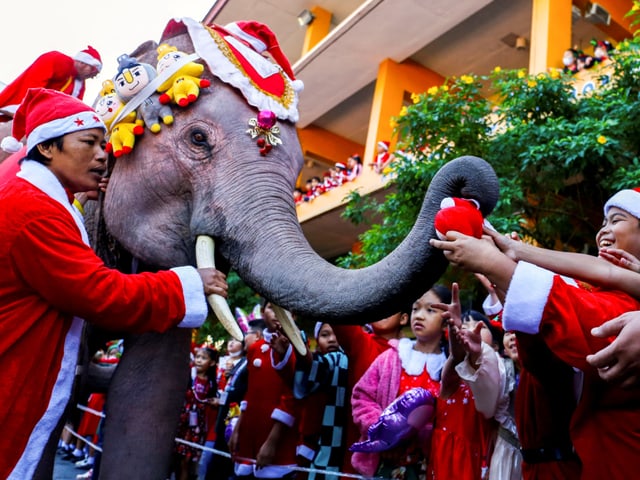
[{"left": 1, "top": 88, "right": 107, "bottom": 153}]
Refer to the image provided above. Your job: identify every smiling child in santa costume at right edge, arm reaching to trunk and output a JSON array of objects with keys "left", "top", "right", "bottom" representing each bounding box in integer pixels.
[{"left": 431, "top": 190, "right": 640, "bottom": 480}]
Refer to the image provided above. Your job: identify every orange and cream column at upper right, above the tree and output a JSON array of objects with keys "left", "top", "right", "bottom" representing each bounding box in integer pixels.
[{"left": 529, "top": 0, "right": 572, "bottom": 74}]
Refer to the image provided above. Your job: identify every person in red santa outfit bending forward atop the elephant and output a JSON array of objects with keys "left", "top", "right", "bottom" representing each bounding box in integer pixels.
[{"left": 0, "top": 46, "right": 102, "bottom": 122}]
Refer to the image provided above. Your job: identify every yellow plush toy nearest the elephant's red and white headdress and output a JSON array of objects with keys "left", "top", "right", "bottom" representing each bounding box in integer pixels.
[{"left": 156, "top": 43, "right": 211, "bottom": 107}]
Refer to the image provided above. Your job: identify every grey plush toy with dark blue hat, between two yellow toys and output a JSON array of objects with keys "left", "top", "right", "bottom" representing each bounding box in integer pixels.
[{"left": 114, "top": 54, "right": 173, "bottom": 133}]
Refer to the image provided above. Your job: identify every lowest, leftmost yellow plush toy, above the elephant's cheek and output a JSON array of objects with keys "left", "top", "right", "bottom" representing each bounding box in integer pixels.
[{"left": 95, "top": 89, "right": 144, "bottom": 157}]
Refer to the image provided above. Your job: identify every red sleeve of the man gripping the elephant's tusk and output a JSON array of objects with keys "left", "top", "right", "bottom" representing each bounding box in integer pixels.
[{"left": 11, "top": 215, "right": 185, "bottom": 332}]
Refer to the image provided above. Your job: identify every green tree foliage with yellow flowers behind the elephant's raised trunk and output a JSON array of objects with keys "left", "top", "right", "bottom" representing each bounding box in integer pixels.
[{"left": 338, "top": 5, "right": 640, "bottom": 298}]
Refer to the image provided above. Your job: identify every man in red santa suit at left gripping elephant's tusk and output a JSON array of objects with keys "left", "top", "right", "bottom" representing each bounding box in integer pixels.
[{"left": 0, "top": 88, "right": 227, "bottom": 480}]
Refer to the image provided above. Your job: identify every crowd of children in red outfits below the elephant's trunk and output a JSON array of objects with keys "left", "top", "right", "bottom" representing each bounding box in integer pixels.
[{"left": 52, "top": 185, "right": 640, "bottom": 480}]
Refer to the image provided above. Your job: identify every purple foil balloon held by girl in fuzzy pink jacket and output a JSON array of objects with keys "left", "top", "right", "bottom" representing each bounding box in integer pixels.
[{"left": 349, "top": 387, "right": 436, "bottom": 453}]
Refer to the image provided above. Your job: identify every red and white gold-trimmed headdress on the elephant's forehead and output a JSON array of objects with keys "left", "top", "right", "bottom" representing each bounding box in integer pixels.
[{"left": 163, "top": 18, "right": 302, "bottom": 123}]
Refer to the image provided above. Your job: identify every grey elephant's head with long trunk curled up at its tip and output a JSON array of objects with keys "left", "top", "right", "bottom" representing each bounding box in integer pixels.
[{"left": 104, "top": 17, "right": 498, "bottom": 330}]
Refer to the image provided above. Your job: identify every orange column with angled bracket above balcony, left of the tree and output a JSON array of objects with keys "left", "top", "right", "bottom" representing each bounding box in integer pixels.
[{"left": 363, "top": 59, "right": 445, "bottom": 175}]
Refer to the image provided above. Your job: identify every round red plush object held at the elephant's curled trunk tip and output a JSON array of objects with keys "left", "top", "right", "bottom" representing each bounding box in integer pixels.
[{"left": 434, "top": 197, "right": 484, "bottom": 240}]
